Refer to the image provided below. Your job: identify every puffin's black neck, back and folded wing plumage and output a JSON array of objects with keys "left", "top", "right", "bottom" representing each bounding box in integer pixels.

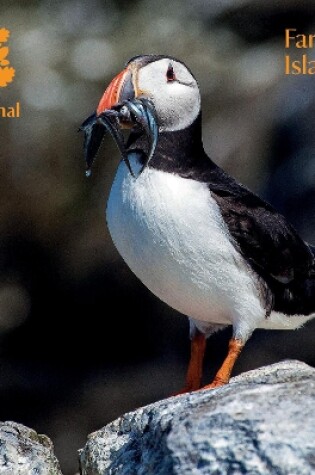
[{"left": 128, "top": 114, "right": 315, "bottom": 317}]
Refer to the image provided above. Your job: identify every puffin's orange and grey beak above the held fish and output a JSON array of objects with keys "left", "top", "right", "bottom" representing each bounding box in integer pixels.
[{"left": 96, "top": 67, "right": 135, "bottom": 116}]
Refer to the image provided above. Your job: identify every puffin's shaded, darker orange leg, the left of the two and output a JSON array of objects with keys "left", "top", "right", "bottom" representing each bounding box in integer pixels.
[{"left": 176, "top": 330, "right": 206, "bottom": 395}]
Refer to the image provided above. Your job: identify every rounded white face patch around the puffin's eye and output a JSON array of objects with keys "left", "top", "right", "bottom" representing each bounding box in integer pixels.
[{"left": 138, "top": 58, "right": 200, "bottom": 132}]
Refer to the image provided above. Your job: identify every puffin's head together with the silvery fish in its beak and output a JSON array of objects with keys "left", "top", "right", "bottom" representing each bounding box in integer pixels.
[{"left": 81, "top": 55, "right": 200, "bottom": 177}]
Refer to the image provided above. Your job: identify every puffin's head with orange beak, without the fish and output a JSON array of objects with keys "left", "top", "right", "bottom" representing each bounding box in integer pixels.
[{"left": 97, "top": 55, "right": 200, "bottom": 131}]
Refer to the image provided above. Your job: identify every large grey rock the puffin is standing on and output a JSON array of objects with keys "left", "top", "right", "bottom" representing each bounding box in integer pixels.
[{"left": 80, "top": 361, "right": 315, "bottom": 475}]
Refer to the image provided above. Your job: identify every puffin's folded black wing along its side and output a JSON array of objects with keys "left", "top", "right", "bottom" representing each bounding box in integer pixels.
[{"left": 209, "top": 176, "right": 314, "bottom": 285}]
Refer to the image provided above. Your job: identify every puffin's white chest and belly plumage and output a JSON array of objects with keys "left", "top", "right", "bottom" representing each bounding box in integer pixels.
[{"left": 107, "top": 156, "right": 264, "bottom": 323}]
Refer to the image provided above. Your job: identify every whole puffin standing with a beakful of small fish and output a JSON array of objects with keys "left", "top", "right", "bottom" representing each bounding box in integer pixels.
[{"left": 81, "top": 55, "right": 315, "bottom": 394}]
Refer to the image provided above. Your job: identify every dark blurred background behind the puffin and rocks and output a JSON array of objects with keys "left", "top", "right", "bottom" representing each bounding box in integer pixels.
[{"left": 0, "top": 0, "right": 315, "bottom": 475}]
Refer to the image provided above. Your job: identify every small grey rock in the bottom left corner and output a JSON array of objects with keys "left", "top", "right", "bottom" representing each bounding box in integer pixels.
[{"left": 0, "top": 422, "right": 62, "bottom": 475}]
